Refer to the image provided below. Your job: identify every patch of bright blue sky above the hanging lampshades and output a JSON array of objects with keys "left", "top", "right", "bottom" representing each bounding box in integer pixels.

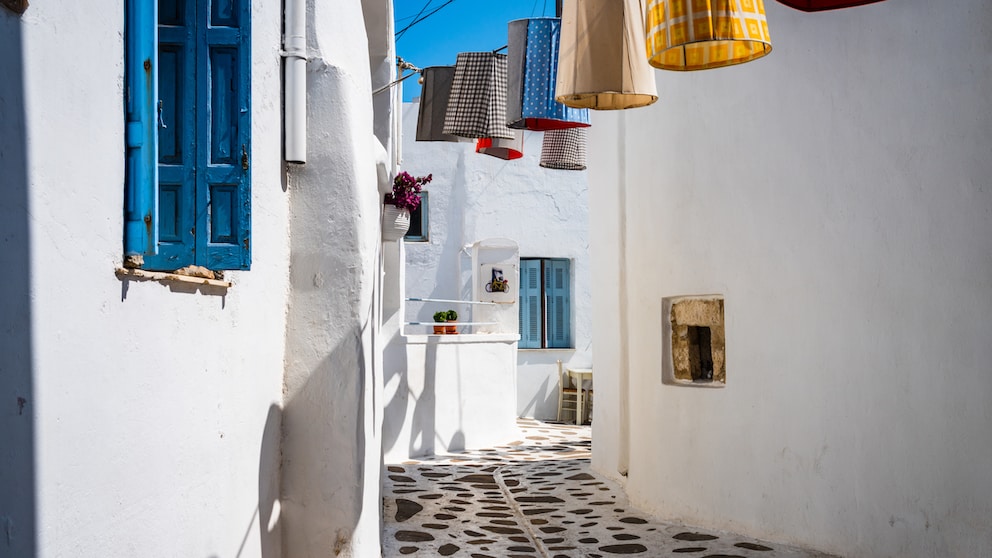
[{"left": 393, "top": 0, "right": 555, "bottom": 101}]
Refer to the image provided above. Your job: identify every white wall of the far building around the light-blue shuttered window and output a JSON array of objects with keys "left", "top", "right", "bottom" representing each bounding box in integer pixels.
[{"left": 401, "top": 103, "right": 592, "bottom": 418}]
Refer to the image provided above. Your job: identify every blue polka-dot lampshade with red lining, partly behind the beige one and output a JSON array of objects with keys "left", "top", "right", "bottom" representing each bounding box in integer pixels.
[{"left": 506, "top": 17, "right": 589, "bottom": 132}]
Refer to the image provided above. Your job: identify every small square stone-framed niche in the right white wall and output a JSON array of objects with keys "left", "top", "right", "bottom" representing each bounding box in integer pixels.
[{"left": 662, "top": 295, "right": 727, "bottom": 387}]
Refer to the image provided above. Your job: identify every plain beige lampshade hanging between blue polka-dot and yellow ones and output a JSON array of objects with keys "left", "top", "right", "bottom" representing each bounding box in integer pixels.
[{"left": 555, "top": 0, "right": 658, "bottom": 110}]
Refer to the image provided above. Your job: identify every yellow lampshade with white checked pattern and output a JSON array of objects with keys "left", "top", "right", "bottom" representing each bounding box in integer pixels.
[{"left": 645, "top": 0, "right": 772, "bottom": 71}]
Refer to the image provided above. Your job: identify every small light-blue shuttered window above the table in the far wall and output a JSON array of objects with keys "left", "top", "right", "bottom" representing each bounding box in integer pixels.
[{"left": 519, "top": 258, "right": 573, "bottom": 349}]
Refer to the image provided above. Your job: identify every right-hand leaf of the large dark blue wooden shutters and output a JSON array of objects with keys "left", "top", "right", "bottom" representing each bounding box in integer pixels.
[{"left": 196, "top": 0, "right": 251, "bottom": 269}]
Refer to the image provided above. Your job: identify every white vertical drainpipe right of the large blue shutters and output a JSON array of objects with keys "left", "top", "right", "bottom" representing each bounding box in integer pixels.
[{"left": 283, "top": 0, "right": 307, "bottom": 163}]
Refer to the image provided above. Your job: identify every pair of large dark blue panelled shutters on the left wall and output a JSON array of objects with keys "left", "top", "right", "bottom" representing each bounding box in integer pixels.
[{"left": 129, "top": 0, "right": 251, "bottom": 270}]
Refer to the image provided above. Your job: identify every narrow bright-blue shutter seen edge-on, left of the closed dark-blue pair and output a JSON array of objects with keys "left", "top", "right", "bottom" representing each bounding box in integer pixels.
[{"left": 124, "top": 0, "right": 158, "bottom": 257}]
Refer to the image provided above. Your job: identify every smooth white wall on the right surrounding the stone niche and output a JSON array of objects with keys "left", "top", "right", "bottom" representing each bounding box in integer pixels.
[{"left": 589, "top": 0, "right": 992, "bottom": 558}]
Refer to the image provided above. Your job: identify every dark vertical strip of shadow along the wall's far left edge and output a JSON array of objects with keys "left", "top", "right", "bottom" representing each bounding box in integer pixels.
[{"left": 0, "top": 12, "right": 37, "bottom": 558}]
